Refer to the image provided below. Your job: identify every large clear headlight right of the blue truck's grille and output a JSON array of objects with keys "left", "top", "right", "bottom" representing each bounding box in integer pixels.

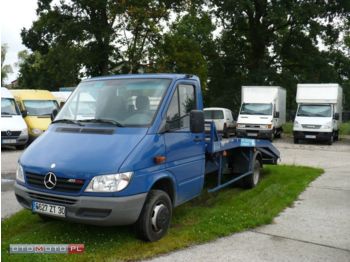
[{"left": 85, "top": 172, "right": 133, "bottom": 192}]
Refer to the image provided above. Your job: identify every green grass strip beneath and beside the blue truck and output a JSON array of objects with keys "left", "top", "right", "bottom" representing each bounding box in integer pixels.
[{"left": 1, "top": 166, "right": 323, "bottom": 261}]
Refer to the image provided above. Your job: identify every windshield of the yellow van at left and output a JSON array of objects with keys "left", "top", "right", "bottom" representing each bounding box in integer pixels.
[{"left": 23, "top": 100, "right": 58, "bottom": 116}]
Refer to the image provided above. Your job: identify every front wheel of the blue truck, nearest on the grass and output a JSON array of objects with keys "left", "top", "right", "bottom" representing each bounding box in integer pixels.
[{"left": 135, "top": 190, "right": 172, "bottom": 242}]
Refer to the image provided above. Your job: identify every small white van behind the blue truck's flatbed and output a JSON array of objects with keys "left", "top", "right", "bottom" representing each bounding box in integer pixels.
[{"left": 204, "top": 107, "right": 236, "bottom": 137}]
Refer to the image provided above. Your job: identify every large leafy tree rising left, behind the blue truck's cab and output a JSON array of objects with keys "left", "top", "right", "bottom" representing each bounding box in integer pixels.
[{"left": 21, "top": 0, "right": 181, "bottom": 85}]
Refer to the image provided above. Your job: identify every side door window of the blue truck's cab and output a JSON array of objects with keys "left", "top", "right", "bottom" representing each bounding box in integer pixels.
[{"left": 167, "top": 85, "right": 196, "bottom": 129}]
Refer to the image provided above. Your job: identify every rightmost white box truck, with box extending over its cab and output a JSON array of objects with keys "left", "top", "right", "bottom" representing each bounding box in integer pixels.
[{"left": 293, "top": 84, "right": 343, "bottom": 145}]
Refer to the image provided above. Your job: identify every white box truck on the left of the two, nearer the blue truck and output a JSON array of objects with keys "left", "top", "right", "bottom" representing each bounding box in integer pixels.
[{"left": 236, "top": 86, "right": 286, "bottom": 141}]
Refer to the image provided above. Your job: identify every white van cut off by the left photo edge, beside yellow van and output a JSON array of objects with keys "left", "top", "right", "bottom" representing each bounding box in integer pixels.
[{"left": 1, "top": 87, "right": 28, "bottom": 149}]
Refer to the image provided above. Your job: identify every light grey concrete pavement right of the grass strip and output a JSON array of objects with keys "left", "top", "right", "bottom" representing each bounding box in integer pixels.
[{"left": 148, "top": 139, "right": 350, "bottom": 262}]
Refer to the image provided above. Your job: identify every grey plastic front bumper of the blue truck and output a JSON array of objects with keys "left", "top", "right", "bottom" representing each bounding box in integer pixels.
[{"left": 15, "top": 183, "right": 147, "bottom": 226}]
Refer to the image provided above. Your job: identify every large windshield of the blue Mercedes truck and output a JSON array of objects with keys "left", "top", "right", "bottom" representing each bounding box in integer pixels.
[{"left": 55, "top": 79, "right": 171, "bottom": 126}]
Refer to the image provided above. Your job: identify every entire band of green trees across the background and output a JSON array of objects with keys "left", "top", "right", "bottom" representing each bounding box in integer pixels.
[{"left": 19, "top": 0, "right": 350, "bottom": 111}]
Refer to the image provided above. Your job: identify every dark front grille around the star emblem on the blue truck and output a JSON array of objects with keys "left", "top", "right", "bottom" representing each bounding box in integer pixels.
[{"left": 26, "top": 173, "right": 84, "bottom": 193}]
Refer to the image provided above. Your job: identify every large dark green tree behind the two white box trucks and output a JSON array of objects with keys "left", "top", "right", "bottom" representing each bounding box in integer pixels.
[{"left": 209, "top": 0, "right": 350, "bottom": 111}]
